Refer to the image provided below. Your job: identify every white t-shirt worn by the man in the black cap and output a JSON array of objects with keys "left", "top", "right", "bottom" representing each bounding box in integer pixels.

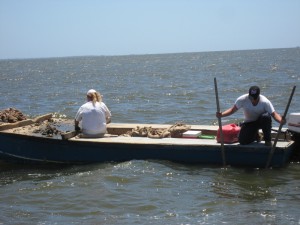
[{"left": 235, "top": 94, "right": 275, "bottom": 122}]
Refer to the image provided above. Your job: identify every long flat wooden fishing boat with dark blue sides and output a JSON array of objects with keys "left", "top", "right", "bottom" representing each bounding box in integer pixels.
[{"left": 0, "top": 114, "right": 294, "bottom": 168}]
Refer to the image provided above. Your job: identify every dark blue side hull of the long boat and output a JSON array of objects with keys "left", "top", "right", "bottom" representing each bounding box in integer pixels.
[{"left": 0, "top": 133, "right": 292, "bottom": 168}]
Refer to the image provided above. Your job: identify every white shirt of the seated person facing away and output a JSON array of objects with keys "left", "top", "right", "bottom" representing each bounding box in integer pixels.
[{"left": 75, "top": 101, "right": 111, "bottom": 135}]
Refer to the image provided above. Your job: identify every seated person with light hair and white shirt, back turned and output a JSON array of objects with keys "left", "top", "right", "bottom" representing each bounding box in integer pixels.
[{"left": 75, "top": 89, "right": 111, "bottom": 138}]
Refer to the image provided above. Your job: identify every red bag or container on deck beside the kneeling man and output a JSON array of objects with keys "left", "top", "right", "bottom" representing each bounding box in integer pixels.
[{"left": 217, "top": 123, "right": 241, "bottom": 144}]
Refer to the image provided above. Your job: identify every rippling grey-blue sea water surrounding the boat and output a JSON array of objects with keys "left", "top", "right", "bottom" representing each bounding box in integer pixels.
[{"left": 0, "top": 48, "right": 300, "bottom": 224}]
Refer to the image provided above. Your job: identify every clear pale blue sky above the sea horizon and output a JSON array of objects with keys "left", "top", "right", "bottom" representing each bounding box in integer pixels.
[{"left": 0, "top": 0, "right": 300, "bottom": 59}]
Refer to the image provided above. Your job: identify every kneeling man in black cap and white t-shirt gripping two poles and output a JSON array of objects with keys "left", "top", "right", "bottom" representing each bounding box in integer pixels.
[{"left": 216, "top": 86, "right": 285, "bottom": 146}]
